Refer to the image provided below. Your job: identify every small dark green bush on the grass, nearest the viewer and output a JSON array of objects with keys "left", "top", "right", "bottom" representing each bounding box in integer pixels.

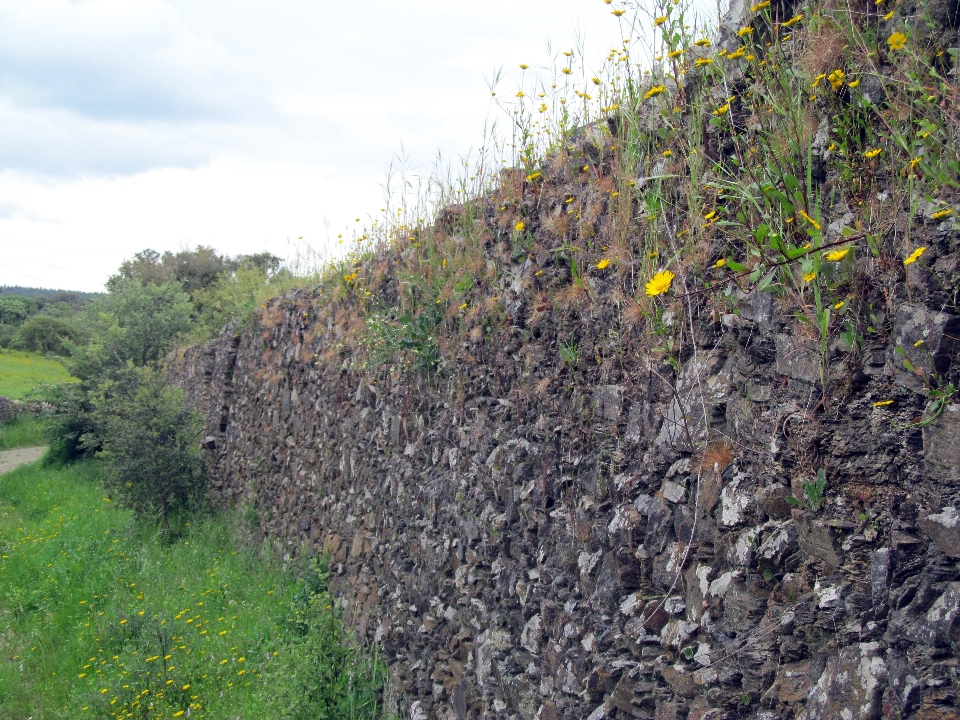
[{"left": 93, "top": 368, "right": 207, "bottom": 530}]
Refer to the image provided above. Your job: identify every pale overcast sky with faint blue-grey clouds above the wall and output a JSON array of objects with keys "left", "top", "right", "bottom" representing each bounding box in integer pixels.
[{"left": 0, "top": 0, "right": 716, "bottom": 291}]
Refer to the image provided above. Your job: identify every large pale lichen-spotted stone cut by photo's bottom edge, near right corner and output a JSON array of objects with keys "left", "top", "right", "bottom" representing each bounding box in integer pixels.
[{"left": 805, "top": 642, "right": 887, "bottom": 720}]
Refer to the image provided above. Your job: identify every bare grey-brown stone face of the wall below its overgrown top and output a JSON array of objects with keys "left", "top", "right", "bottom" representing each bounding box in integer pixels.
[{"left": 171, "top": 268, "right": 960, "bottom": 720}]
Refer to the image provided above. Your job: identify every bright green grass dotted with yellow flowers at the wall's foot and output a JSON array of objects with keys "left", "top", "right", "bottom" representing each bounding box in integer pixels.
[{"left": 0, "top": 460, "right": 390, "bottom": 720}]
